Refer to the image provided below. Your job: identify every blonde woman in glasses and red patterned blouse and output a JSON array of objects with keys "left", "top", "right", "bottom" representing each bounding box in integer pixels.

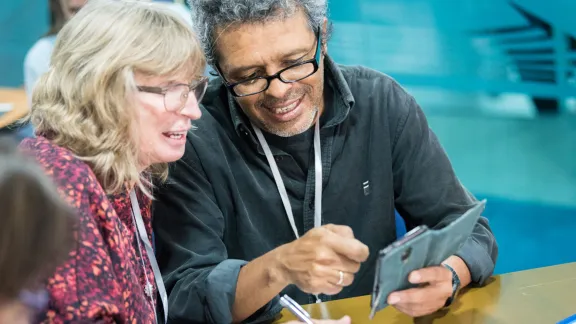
[{"left": 21, "top": 0, "right": 207, "bottom": 323}]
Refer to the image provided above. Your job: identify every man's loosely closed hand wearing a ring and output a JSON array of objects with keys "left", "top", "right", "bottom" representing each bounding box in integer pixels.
[{"left": 277, "top": 225, "right": 369, "bottom": 295}]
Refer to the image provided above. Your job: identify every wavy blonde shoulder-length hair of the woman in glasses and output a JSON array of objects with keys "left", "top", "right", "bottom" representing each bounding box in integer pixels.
[{"left": 30, "top": 0, "right": 206, "bottom": 196}]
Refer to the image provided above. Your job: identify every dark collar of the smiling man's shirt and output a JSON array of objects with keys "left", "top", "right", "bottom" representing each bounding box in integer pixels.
[{"left": 227, "top": 55, "right": 355, "bottom": 138}]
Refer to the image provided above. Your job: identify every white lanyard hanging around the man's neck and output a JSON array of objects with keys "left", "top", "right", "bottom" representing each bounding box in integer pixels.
[{"left": 252, "top": 120, "right": 322, "bottom": 238}]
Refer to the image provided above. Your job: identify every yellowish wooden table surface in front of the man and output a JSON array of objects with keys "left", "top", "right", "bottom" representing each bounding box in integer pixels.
[{"left": 279, "top": 263, "right": 576, "bottom": 324}]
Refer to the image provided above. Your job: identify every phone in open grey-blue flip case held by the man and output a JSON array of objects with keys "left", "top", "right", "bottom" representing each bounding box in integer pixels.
[{"left": 370, "top": 200, "right": 486, "bottom": 318}]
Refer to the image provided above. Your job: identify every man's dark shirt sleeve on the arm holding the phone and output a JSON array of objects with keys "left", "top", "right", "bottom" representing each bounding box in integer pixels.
[{"left": 388, "top": 86, "right": 498, "bottom": 285}]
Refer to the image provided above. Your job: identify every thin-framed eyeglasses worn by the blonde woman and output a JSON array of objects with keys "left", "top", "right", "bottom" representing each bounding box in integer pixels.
[{"left": 137, "top": 77, "right": 208, "bottom": 112}]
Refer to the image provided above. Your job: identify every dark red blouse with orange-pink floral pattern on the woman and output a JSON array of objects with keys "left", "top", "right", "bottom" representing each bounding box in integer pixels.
[{"left": 20, "top": 137, "right": 156, "bottom": 323}]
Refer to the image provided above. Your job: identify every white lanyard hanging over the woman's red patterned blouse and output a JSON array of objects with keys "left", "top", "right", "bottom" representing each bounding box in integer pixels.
[{"left": 130, "top": 190, "right": 168, "bottom": 323}]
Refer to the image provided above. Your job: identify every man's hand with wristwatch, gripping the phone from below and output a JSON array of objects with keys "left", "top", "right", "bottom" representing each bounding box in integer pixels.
[{"left": 388, "top": 256, "right": 470, "bottom": 317}]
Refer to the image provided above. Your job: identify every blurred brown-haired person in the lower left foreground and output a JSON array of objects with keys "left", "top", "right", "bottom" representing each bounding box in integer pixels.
[{"left": 0, "top": 136, "right": 76, "bottom": 324}]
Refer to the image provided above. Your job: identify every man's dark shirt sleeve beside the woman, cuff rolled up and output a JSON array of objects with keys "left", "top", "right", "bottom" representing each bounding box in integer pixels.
[{"left": 154, "top": 139, "right": 280, "bottom": 323}]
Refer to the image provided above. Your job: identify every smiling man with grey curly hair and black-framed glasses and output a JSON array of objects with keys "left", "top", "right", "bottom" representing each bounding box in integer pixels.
[{"left": 155, "top": 0, "right": 498, "bottom": 323}]
